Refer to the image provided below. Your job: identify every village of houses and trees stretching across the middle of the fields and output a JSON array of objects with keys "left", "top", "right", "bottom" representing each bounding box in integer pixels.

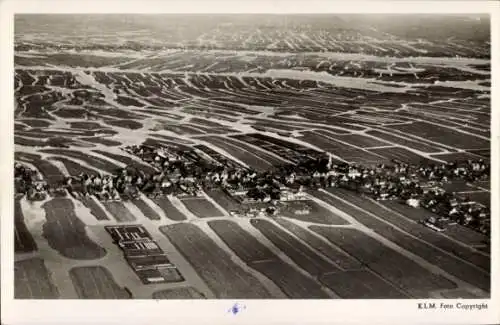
[{"left": 15, "top": 145, "right": 490, "bottom": 234}]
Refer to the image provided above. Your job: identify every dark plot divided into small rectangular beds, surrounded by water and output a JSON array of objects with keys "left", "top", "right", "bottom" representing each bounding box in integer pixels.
[{"left": 104, "top": 225, "right": 184, "bottom": 284}]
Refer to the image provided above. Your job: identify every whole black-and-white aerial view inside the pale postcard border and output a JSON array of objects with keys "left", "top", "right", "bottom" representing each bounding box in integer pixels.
[{"left": 13, "top": 14, "right": 491, "bottom": 300}]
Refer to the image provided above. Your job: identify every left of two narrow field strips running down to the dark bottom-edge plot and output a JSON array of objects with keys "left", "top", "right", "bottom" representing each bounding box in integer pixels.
[{"left": 250, "top": 219, "right": 339, "bottom": 277}]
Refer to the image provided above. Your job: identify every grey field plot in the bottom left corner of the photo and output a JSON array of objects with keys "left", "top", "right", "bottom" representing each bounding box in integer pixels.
[{"left": 14, "top": 258, "right": 59, "bottom": 299}]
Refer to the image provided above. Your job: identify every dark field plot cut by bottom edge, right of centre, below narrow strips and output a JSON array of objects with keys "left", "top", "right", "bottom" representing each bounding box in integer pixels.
[{"left": 320, "top": 270, "right": 409, "bottom": 299}]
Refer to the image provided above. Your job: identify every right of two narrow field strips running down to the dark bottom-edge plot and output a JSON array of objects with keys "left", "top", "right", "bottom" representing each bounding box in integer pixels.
[{"left": 276, "top": 218, "right": 362, "bottom": 270}]
